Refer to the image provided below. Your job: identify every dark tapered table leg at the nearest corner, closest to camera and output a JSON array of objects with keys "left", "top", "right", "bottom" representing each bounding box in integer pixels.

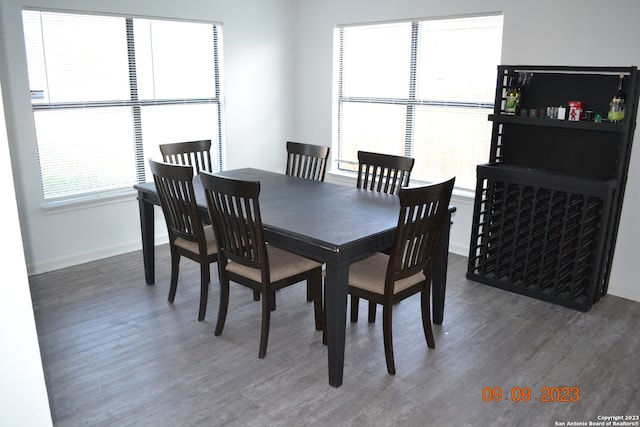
[{"left": 324, "top": 261, "right": 349, "bottom": 387}]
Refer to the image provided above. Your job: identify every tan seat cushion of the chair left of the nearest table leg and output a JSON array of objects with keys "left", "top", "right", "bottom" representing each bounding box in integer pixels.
[{"left": 227, "top": 245, "right": 322, "bottom": 282}]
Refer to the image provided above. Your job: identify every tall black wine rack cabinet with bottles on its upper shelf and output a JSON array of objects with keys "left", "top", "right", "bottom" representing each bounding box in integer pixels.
[{"left": 467, "top": 66, "right": 638, "bottom": 311}]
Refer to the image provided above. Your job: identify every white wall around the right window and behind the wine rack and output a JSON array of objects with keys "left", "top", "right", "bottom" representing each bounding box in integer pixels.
[{"left": 293, "top": 0, "right": 640, "bottom": 301}]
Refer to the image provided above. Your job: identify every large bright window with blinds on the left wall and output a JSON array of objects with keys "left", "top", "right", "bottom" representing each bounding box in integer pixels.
[{"left": 22, "top": 10, "right": 223, "bottom": 203}]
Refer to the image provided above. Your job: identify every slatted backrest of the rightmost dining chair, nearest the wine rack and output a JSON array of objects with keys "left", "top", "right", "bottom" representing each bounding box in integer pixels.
[{"left": 385, "top": 177, "right": 455, "bottom": 292}]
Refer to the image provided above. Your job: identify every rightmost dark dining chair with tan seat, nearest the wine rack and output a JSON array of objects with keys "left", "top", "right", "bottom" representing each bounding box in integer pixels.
[{"left": 349, "top": 178, "right": 455, "bottom": 375}]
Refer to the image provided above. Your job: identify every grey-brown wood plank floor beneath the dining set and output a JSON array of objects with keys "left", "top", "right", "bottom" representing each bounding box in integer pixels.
[{"left": 30, "top": 246, "right": 640, "bottom": 427}]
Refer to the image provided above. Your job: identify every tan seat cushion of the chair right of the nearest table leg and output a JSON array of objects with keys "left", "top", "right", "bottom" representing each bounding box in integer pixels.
[{"left": 349, "top": 252, "right": 426, "bottom": 295}]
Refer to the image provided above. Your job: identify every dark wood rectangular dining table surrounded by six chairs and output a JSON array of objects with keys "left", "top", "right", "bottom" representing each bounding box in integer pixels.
[{"left": 134, "top": 169, "right": 455, "bottom": 387}]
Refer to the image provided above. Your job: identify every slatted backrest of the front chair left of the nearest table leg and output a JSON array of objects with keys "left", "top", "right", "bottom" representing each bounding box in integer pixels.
[{"left": 200, "top": 172, "right": 269, "bottom": 279}]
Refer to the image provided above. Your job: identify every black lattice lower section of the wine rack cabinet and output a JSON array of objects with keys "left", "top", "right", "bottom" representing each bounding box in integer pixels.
[{"left": 468, "top": 167, "right": 613, "bottom": 310}]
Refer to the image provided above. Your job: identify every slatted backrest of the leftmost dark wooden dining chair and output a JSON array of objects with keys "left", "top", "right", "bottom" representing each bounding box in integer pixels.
[{"left": 149, "top": 159, "right": 206, "bottom": 247}]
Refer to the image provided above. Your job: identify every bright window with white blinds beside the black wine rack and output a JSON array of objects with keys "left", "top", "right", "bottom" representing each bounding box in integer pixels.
[{"left": 334, "top": 15, "right": 502, "bottom": 189}]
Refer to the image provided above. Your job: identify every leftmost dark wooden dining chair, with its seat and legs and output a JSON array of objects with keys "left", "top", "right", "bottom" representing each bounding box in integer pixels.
[{"left": 149, "top": 159, "right": 218, "bottom": 320}]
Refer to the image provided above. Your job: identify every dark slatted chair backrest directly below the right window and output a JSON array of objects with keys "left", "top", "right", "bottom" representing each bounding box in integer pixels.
[{"left": 356, "top": 151, "right": 415, "bottom": 194}]
